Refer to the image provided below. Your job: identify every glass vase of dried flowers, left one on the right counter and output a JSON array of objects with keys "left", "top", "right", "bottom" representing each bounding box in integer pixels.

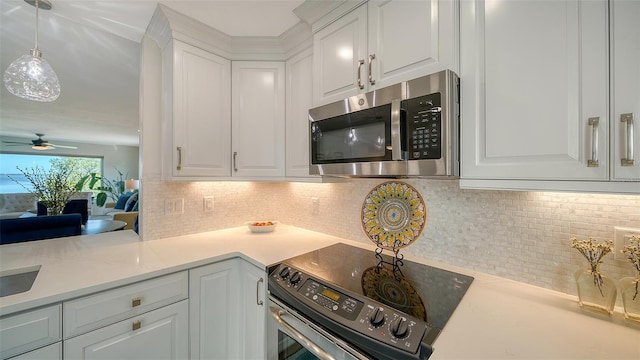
[{"left": 571, "top": 238, "right": 617, "bottom": 315}]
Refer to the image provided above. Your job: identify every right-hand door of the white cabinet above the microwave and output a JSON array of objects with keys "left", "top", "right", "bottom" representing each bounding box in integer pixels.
[{"left": 366, "top": 0, "right": 459, "bottom": 88}]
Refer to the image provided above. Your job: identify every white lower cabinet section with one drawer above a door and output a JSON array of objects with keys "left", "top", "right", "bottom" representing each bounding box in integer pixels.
[{"left": 63, "top": 271, "right": 189, "bottom": 360}]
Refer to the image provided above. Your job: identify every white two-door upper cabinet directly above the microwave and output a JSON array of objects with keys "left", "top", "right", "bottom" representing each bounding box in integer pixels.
[{"left": 313, "top": 0, "right": 458, "bottom": 106}]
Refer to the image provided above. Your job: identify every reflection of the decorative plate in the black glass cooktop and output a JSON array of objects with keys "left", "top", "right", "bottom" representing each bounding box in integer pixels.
[{"left": 362, "top": 266, "right": 427, "bottom": 321}]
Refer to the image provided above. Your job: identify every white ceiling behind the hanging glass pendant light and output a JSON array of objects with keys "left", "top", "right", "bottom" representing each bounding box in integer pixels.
[{"left": 0, "top": 0, "right": 303, "bottom": 146}]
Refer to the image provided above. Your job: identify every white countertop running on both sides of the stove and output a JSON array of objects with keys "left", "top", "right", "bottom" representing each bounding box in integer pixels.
[{"left": 0, "top": 224, "right": 640, "bottom": 360}]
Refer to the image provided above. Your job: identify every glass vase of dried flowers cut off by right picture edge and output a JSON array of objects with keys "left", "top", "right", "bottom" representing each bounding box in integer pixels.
[{"left": 620, "top": 235, "right": 640, "bottom": 324}]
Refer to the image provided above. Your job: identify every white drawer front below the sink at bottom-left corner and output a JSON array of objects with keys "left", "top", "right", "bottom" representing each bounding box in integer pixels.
[{"left": 0, "top": 305, "right": 61, "bottom": 359}]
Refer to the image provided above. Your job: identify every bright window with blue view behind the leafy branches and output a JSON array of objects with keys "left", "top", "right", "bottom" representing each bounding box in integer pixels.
[{"left": 0, "top": 153, "right": 103, "bottom": 194}]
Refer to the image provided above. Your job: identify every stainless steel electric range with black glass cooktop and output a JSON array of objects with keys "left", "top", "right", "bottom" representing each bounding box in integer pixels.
[{"left": 267, "top": 243, "right": 473, "bottom": 360}]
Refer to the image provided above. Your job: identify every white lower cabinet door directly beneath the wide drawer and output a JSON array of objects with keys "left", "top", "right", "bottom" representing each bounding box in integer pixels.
[{"left": 63, "top": 300, "right": 189, "bottom": 360}]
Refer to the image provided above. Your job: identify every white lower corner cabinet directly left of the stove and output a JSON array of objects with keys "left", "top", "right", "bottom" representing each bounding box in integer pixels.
[{"left": 189, "top": 259, "right": 266, "bottom": 360}]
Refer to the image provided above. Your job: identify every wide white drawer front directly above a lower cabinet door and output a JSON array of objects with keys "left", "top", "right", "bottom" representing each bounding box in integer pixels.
[{"left": 63, "top": 271, "right": 189, "bottom": 339}]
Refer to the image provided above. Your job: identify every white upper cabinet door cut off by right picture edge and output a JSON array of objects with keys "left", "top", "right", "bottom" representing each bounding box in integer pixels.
[{"left": 610, "top": 0, "right": 640, "bottom": 181}]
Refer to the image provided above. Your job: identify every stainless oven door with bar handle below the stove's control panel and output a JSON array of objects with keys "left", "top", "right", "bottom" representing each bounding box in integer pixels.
[{"left": 267, "top": 298, "right": 370, "bottom": 360}]
